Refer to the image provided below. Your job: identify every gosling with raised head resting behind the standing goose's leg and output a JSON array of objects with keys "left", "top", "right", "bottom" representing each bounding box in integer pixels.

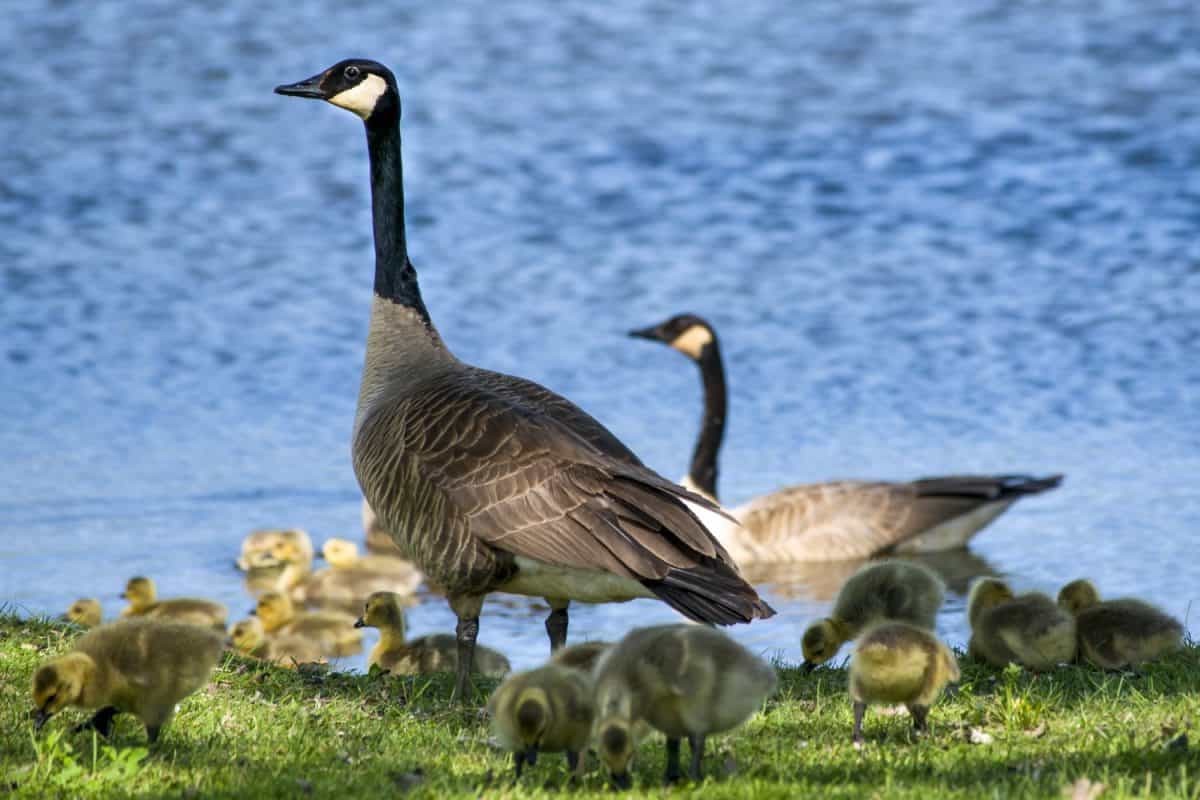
[{"left": 354, "top": 591, "right": 512, "bottom": 678}]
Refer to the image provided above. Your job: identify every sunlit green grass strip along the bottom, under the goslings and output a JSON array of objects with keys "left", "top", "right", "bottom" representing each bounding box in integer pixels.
[{"left": 0, "top": 615, "right": 1200, "bottom": 800}]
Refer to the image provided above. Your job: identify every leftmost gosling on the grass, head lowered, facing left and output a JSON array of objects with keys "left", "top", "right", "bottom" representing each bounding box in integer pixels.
[{"left": 32, "top": 619, "right": 223, "bottom": 744}]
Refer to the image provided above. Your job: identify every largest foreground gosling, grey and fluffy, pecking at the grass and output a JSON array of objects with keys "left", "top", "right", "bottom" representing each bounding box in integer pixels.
[{"left": 595, "top": 625, "right": 776, "bottom": 789}]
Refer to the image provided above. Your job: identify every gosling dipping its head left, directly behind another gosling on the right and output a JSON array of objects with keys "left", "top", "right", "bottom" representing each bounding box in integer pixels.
[{"left": 800, "top": 560, "right": 946, "bottom": 672}]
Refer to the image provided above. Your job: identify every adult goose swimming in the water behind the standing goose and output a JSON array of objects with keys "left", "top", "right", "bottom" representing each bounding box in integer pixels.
[{"left": 630, "top": 314, "right": 1062, "bottom": 567}]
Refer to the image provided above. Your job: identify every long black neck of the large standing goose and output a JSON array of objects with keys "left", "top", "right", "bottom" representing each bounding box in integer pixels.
[{"left": 366, "top": 113, "right": 430, "bottom": 324}]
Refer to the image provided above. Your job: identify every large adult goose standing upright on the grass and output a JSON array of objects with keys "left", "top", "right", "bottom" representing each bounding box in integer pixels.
[{"left": 276, "top": 59, "right": 774, "bottom": 702}]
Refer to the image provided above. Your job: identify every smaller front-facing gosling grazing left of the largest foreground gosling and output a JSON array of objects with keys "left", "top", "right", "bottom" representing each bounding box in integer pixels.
[{"left": 487, "top": 654, "right": 595, "bottom": 780}]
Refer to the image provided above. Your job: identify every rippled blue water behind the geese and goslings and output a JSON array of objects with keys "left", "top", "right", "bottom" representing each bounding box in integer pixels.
[{"left": 0, "top": 0, "right": 1200, "bottom": 666}]
